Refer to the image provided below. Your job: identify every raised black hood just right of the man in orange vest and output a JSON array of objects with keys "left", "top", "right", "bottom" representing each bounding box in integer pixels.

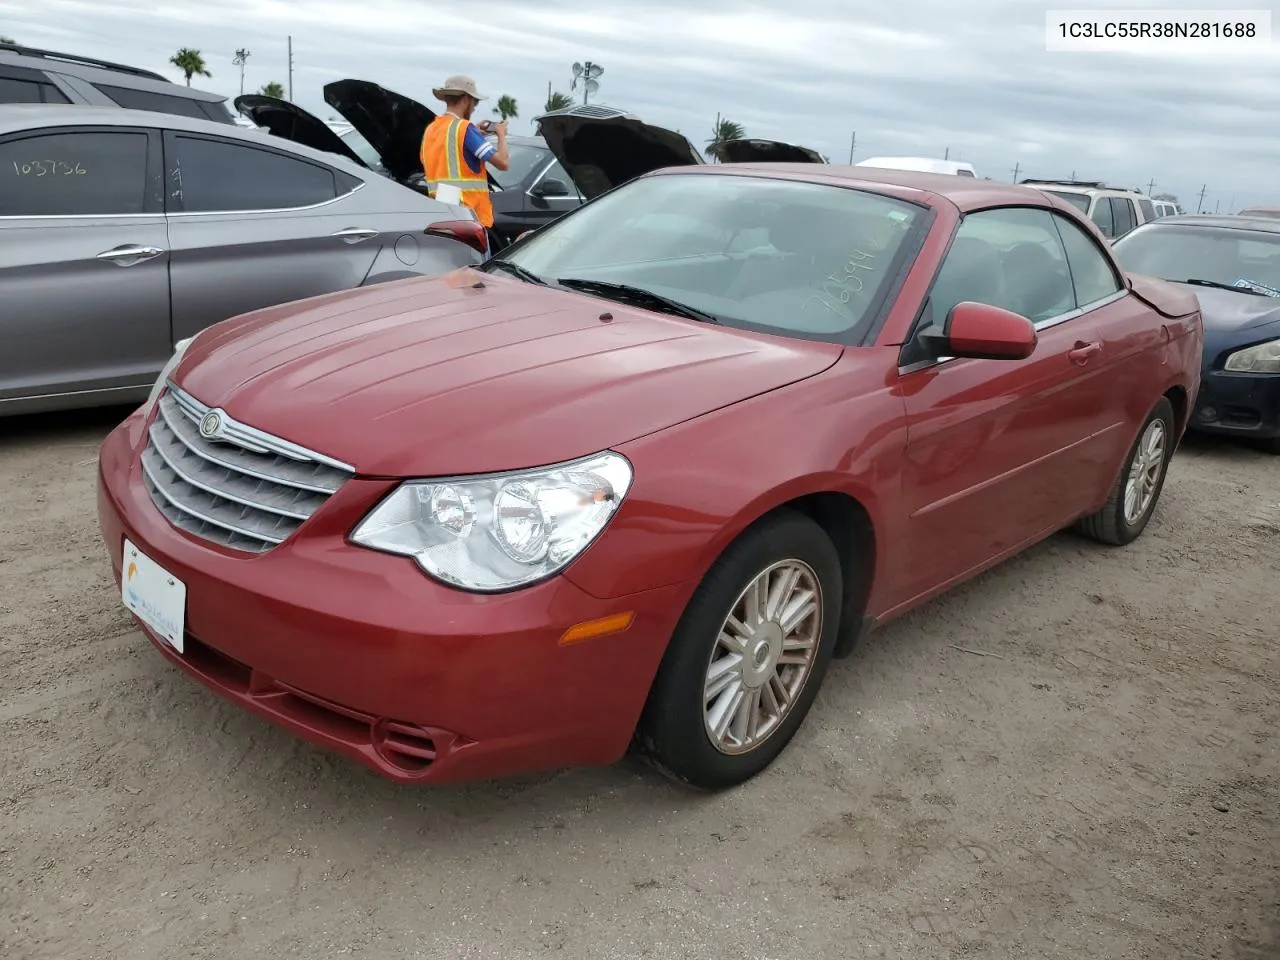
[{"left": 538, "top": 114, "right": 703, "bottom": 200}]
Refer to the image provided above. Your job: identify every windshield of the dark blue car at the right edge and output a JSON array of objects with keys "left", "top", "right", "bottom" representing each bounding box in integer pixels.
[{"left": 1112, "top": 223, "right": 1280, "bottom": 288}]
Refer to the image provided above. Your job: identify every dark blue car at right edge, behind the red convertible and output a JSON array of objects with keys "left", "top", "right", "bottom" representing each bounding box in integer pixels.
[{"left": 1114, "top": 214, "right": 1280, "bottom": 454}]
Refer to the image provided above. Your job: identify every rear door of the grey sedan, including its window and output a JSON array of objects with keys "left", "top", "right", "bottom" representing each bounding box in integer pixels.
[{"left": 165, "top": 131, "right": 378, "bottom": 338}]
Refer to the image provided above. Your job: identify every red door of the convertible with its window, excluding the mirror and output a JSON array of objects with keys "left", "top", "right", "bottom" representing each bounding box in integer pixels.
[{"left": 899, "top": 207, "right": 1115, "bottom": 602}]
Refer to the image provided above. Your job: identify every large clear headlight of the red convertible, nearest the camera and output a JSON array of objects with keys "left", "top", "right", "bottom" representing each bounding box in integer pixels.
[{"left": 351, "top": 452, "right": 632, "bottom": 593}]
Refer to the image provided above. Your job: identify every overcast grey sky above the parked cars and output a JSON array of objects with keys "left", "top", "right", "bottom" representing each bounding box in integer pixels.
[{"left": 0, "top": 0, "right": 1280, "bottom": 211}]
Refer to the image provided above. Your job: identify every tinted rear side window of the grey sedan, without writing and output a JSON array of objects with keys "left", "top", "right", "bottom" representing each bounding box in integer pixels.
[{"left": 169, "top": 136, "right": 338, "bottom": 212}]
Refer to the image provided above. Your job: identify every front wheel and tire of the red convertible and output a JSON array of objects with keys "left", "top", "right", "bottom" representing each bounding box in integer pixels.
[{"left": 637, "top": 511, "right": 842, "bottom": 790}]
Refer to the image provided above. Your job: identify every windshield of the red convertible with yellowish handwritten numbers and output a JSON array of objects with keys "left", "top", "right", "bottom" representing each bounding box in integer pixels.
[{"left": 507, "top": 174, "right": 928, "bottom": 343}]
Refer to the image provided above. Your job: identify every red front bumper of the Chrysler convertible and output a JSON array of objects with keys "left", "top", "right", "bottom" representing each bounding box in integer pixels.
[{"left": 97, "top": 413, "right": 691, "bottom": 782}]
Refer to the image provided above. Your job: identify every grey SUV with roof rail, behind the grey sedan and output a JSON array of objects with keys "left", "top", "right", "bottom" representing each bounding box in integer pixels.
[{"left": 0, "top": 44, "right": 234, "bottom": 123}]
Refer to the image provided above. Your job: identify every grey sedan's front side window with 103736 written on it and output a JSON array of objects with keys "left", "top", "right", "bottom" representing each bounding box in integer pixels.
[{"left": 0, "top": 131, "right": 148, "bottom": 216}]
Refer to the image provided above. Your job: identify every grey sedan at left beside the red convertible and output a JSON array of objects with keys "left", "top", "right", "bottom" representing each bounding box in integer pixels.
[{"left": 0, "top": 104, "right": 485, "bottom": 416}]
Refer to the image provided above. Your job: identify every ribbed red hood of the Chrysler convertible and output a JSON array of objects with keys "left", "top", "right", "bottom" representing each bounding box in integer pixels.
[{"left": 175, "top": 269, "right": 842, "bottom": 477}]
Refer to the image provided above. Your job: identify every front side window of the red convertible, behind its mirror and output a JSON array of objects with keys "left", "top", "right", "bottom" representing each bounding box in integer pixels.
[{"left": 929, "top": 207, "right": 1075, "bottom": 323}]
